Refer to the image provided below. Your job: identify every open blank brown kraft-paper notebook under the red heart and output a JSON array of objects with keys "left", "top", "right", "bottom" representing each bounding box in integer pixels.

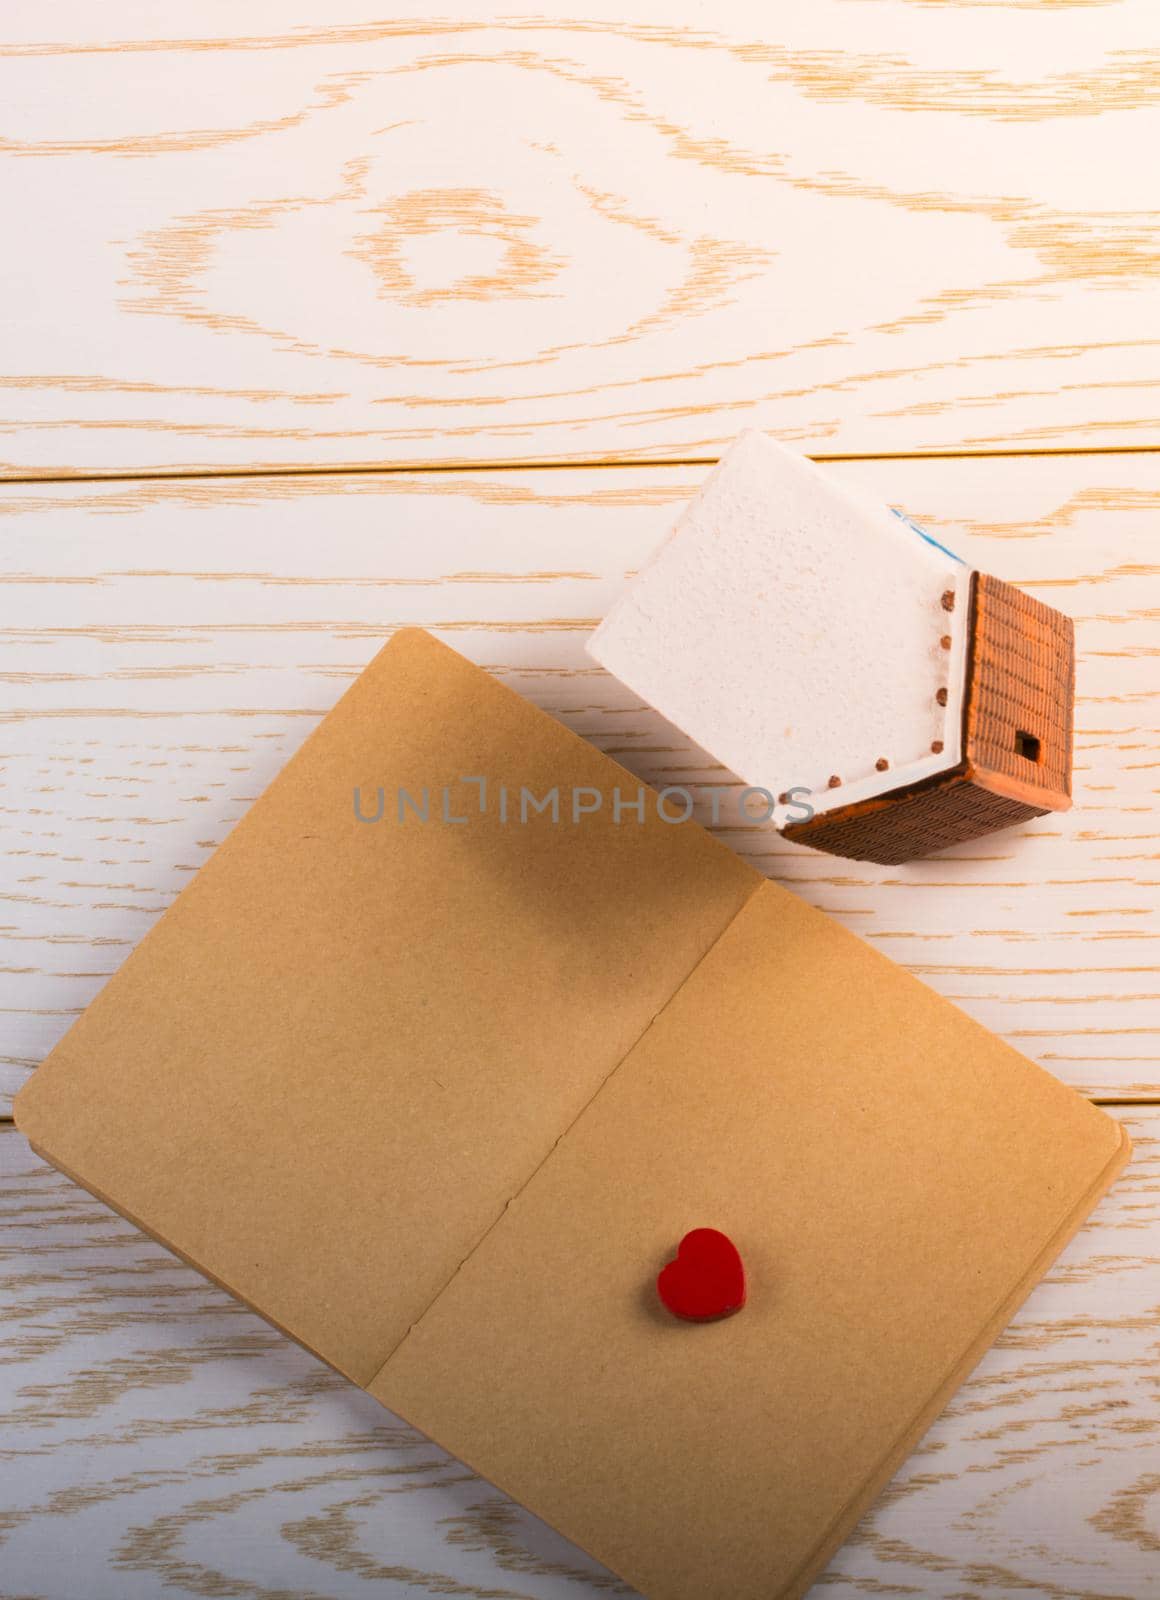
[{"left": 16, "top": 630, "right": 1126, "bottom": 1600}]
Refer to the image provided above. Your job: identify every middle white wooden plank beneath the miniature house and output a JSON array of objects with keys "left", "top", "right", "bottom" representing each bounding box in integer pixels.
[{"left": 0, "top": 456, "right": 1160, "bottom": 1098}]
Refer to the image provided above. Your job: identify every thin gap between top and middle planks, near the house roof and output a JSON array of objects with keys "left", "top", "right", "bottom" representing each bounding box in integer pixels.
[{"left": 0, "top": 445, "right": 1160, "bottom": 493}]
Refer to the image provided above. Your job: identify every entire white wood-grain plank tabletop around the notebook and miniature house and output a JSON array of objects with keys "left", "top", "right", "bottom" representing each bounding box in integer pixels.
[{"left": 0, "top": 12, "right": 1160, "bottom": 1600}]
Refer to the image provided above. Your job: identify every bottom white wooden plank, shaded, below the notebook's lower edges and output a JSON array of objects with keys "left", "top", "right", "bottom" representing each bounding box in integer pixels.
[{"left": 0, "top": 1109, "right": 1160, "bottom": 1600}]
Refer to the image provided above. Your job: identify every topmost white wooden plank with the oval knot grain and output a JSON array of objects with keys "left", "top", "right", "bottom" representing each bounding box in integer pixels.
[{"left": 0, "top": 0, "right": 1160, "bottom": 475}]
